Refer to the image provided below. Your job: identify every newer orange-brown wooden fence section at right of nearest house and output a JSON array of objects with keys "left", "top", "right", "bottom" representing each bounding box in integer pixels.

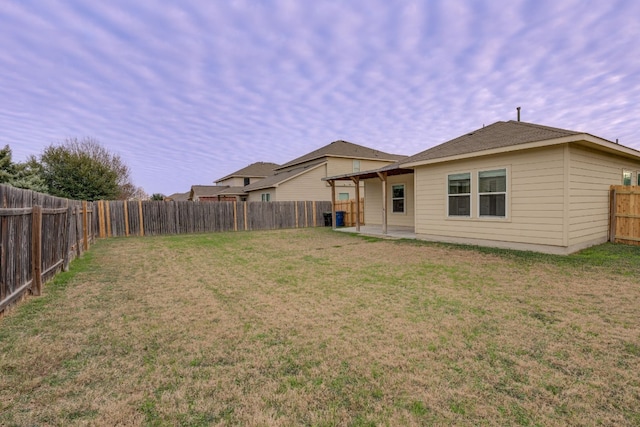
[{"left": 609, "top": 185, "right": 640, "bottom": 245}]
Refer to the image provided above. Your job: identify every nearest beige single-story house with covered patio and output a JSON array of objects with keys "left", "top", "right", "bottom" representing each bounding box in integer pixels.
[{"left": 327, "top": 121, "right": 640, "bottom": 254}]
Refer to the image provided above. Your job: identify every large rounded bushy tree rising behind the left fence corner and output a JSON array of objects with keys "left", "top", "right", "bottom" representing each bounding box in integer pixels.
[{"left": 40, "top": 138, "right": 135, "bottom": 200}]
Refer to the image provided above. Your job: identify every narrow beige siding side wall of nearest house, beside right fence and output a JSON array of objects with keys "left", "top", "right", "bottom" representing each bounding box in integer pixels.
[{"left": 568, "top": 144, "right": 640, "bottom": 248}]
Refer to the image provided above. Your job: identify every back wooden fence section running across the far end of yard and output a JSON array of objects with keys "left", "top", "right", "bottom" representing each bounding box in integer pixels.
[{"left": 96, "top": 201, "right": 331, "bottom": 237}]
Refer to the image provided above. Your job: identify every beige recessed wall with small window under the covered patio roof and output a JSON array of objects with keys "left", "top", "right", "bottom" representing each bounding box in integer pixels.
[{"left": 364, "top": 174, "right": 415, "bottom": 227}]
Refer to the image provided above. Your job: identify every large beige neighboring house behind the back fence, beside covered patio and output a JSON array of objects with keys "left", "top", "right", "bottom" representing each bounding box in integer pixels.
[{"left": 244, "top": 141, "right": 406, "bottom": 201}]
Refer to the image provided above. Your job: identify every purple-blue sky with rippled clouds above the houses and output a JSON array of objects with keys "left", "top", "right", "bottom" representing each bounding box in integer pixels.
[{"left": 0, "top": 0, "right": 640, "bottom": 194}]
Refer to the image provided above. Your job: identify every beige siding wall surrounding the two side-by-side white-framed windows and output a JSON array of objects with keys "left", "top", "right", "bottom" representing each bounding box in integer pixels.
[{"left": 415, "top": 146, "right": 566, "bottom": 252}]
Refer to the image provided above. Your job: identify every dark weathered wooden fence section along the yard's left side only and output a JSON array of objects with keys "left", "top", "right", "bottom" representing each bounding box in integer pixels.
[{"left": 0, "top": 185, "right": 95, "bottom": 313}]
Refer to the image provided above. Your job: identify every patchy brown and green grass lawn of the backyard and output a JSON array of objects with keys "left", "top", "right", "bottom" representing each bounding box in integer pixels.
[{"left": 0, "top": 229, "right": 640, "bottom": 426}]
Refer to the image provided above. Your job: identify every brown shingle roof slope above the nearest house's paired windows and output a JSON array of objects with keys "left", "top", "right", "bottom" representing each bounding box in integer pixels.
[{"left": 399, "top": 120, "right": 584, "bottom": 165}]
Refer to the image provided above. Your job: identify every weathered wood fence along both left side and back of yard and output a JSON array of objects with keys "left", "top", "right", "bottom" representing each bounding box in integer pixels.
[{"left": 0, "top": 185, "right": 331, "bottom": 314}]
